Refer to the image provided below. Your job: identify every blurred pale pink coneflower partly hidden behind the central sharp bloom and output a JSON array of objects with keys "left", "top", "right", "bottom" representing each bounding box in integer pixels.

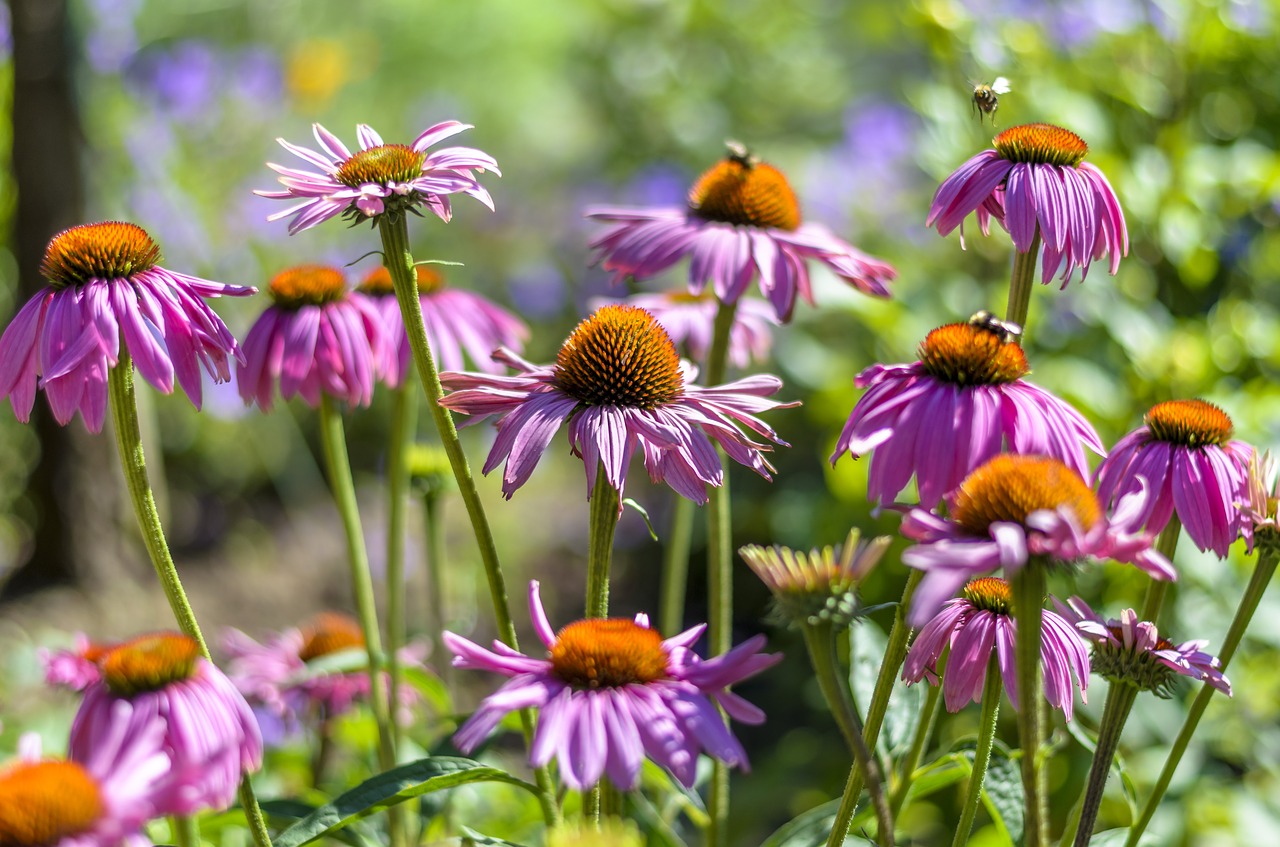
[{"left": 591, "top": 290, "right": 778, "bottom": 368}]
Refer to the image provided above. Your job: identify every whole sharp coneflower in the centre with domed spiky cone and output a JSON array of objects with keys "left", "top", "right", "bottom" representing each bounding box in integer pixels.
[{"left": 440, "top": 306, "right": 788, "bottom": 503}]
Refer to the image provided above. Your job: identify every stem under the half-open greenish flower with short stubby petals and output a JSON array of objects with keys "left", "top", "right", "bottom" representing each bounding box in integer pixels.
[{"left": 804, "top": 623, "right": 893, "bottom": 847}]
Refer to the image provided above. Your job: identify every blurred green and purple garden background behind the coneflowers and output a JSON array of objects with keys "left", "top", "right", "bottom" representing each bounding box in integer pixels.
[{"left": 0, "top": 0, "right": 1280, "bottom": 846}]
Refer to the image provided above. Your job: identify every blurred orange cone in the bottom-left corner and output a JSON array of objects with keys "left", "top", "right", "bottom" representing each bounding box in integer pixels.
[{"left": 0, "top": 761, "right": 105, "bottom": 847}]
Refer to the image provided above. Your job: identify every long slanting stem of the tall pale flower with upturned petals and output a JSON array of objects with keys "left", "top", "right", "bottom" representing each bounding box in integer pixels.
[{"left": 378, "top": 215, "right": 559, "bottom": 827}]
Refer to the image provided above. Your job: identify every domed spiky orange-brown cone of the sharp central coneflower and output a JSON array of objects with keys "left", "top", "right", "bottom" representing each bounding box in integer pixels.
[{"left": 556, "top": 306, "right": 685, "bottom": 409}]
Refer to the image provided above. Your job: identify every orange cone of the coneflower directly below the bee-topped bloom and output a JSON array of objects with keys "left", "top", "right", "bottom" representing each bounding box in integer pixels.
[{"left": 951, "top": 453, "right": 1102, "bottom": 535}]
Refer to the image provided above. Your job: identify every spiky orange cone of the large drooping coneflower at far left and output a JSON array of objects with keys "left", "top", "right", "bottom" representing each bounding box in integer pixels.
[{"left": 40, "top": 220, "right": 160, "bottom": 288}]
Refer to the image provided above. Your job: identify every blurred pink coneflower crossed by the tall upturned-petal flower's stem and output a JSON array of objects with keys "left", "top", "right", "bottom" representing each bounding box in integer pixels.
[{"left": 357, "top": 265, "right": 529, "bottom": 388}]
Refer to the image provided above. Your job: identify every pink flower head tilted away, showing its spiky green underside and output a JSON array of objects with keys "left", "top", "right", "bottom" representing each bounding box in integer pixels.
[{"left": 1053, "top": 598, "right": 1231, "bottom": 697}]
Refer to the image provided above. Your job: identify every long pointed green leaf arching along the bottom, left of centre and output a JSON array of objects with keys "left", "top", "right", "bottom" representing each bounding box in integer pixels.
[{"left": 273, "top": 756, "right": 538, "bottom": 847}]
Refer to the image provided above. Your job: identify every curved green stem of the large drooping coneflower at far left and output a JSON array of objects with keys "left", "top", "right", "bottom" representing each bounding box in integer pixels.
[{"left": 106, "top": 350, "right": 271, "bottom": 847}]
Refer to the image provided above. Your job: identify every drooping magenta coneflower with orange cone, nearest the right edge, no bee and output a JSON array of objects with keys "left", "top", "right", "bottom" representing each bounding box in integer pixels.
[{"left": 1098, "top": 400, "right": 1253, "bottom": 558}]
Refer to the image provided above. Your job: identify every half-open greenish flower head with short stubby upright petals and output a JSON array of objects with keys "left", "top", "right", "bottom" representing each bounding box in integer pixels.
[{"left": 739, "top": 528, "right": 891, "bottom": 627}]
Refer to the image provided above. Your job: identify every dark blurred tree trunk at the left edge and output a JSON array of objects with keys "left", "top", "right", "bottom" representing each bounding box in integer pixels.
[{"left": 3, "top": 0, "right": 119, "bottom": 599}]
